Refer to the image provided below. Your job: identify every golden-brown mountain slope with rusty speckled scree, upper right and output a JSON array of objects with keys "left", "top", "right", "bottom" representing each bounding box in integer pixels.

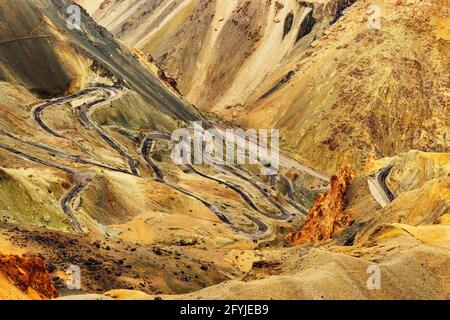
[{"left": 239, "top": 1, "right": 450, "bottom": 171}]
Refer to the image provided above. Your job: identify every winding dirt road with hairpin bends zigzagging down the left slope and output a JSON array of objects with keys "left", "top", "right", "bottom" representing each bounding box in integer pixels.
[{"left": 25, "top": 87, "right": 306, "bottom": 239}]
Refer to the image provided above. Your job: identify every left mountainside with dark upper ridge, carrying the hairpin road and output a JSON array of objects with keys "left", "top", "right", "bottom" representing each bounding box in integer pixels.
[{"left": 0, "top": 0, "right": 314, "bottom": 298}]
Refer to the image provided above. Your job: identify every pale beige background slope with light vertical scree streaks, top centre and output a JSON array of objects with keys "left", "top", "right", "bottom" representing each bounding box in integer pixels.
[{"left": 78, "top": 0, "right": 353, "bottom": 109}]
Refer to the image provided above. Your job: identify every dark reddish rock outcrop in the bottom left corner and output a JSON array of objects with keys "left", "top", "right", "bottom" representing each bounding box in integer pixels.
[{"left": 0, "top": 253, "right": 58, "bottom": 299}]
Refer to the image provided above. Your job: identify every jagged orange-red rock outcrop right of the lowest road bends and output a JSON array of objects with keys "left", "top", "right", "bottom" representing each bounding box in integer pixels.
[{"left": 286, "top": 165, "right": 353, "bottom": 244}]
